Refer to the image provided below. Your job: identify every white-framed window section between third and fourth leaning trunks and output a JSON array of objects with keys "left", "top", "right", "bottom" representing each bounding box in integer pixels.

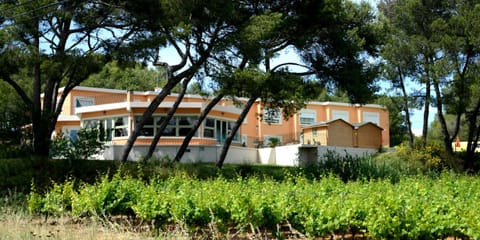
[{"left": 203, "top": 118, "right": 240, "bottom": 143}]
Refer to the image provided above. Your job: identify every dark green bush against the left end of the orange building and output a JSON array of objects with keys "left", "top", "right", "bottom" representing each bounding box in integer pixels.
[{"left": 50, "top": 128, "right": 105, "bottom": 160}]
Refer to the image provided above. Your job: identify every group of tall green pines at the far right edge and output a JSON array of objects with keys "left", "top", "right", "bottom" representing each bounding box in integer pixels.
[{"left": 379, "top": 0, "right": 480, "bottom": 167}]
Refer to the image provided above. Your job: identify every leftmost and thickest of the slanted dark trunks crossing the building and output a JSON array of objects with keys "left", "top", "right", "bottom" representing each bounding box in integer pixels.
[{"left": 120, "top": 79, "right": 180, "bottom": 162}]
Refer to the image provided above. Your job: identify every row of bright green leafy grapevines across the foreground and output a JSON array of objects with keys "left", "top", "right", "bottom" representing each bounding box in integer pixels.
[{"left": 29, "top": 172, "right": 480, "bottom": 239}]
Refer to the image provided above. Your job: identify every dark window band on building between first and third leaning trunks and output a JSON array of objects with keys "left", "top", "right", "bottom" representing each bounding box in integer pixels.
[{"left": 135, "top": 116, "right": 198, "bottom": 137}]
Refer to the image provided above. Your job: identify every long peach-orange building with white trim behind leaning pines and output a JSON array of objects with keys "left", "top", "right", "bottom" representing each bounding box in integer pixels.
[{"left": 55, "top": 87, "right": 389, "bottom": 159}]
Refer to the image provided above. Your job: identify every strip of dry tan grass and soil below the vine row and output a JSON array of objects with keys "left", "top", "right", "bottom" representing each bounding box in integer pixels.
[{"left": 0, "top": 215, "right": 372, "bottom": 240}]
